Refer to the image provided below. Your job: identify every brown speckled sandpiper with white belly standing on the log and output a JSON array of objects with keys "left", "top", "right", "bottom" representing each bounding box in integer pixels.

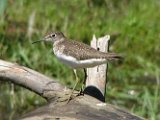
[{"left": 33, "top": 32, "right": 121, "bottom": 100}]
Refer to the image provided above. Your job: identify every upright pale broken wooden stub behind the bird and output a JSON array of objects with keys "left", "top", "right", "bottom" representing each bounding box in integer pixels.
[{"left": 84, "top": 35, "right": 110, "bottom": 102}]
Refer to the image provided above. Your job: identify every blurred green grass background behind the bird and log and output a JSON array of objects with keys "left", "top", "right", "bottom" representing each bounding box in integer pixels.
[{"left": 0, "top": 0, "right": 160, "bottom": 120}]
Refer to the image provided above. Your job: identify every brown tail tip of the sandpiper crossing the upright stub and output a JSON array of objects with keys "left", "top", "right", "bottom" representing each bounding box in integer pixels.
[{"left": 105, "top": 53, "right": 123, "bottom": 61}]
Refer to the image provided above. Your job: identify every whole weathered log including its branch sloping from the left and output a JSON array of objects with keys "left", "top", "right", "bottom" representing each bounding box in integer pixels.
[{"left": 0, "top": 60, "right": 142, "bottom": 120}]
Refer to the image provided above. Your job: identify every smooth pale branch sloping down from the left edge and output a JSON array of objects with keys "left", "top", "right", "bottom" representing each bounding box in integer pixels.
[{"left": 0, "top": 60, "right": 67, "bottom": 100}]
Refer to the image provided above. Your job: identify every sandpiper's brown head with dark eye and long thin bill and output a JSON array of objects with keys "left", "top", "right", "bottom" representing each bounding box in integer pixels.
[{"left": 33, "top": 32, "right": 65, "bottom": 44}]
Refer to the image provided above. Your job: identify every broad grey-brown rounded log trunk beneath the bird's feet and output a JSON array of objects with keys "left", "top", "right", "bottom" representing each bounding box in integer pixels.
[{"left": 21, "top": 95, "right": 142, "bottom": 120}]
